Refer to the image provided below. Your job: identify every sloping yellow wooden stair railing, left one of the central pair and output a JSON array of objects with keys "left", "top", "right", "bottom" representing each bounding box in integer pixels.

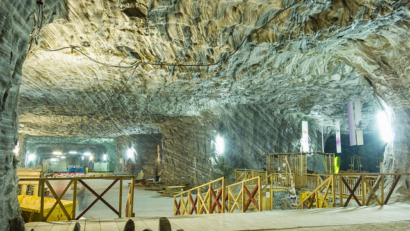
[{"left": 174, "top": 177, "right": 226, "bottom": 215}]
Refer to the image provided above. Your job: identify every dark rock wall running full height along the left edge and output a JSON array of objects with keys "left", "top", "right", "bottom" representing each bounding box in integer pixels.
[{"left": 0, "top": 0, "right": 65, "bottom": 231}]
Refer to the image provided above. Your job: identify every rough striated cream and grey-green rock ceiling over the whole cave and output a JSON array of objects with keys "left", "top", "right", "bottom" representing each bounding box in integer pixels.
[{"left": 18, "top": 0, "right": 410, "bottom": 137}]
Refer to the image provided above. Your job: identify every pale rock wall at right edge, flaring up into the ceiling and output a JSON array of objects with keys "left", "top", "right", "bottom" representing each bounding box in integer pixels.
[{"left": 330, "top": 6, "right": 410, "bottom": 200}]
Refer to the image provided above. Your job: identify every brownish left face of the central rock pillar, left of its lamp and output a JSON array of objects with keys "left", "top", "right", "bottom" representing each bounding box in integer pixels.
[{"left": 159, "top": 113, "right": 216, "bottom": 187}]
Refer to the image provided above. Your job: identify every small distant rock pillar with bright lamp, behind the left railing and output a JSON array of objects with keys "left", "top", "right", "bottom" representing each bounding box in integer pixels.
[{"left": 115, "top": 134, "right": 161, "bottom": 178}]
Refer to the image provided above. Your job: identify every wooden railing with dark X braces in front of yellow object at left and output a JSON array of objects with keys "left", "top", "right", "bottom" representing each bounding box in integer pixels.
[{"left": 20, "top": 176, "right": 134, "bottom": 221}]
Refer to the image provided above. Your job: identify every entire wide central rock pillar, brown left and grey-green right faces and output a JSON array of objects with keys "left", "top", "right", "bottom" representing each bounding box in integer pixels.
[{"left": 160, "top": 105, "right": 330, "bottom": 186}]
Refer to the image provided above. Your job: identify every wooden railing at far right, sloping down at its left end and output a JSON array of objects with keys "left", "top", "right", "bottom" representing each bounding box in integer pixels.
[{"left": 297, "top": 173, "right": 410, "bottom": 208}]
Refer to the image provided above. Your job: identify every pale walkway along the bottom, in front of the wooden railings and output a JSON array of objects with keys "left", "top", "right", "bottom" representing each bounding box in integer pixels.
[{"left": 26, "top": 204, "right": 410, "bottom": 231}]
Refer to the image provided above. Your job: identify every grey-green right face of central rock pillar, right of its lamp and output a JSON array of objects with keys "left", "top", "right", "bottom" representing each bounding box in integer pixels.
[{"left": 218, "top": 105, "right": 331, "bottom": 179}]
